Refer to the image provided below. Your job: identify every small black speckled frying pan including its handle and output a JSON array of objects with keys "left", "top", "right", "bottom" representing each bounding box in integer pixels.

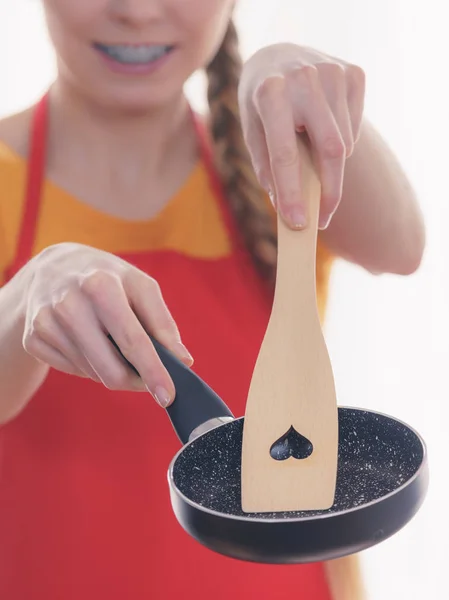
[{"left": 111, "top": 338, "right": 428, "bottom": 564}]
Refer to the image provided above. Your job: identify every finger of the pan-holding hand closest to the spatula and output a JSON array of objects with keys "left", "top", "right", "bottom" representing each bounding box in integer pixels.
[{"left": 123, "top": 269, "right": 193, "bottom": 367}]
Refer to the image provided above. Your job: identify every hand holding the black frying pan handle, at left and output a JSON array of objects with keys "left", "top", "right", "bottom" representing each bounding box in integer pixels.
[{"left": 19, "top": 244, "right": 193, "bottom": 408}]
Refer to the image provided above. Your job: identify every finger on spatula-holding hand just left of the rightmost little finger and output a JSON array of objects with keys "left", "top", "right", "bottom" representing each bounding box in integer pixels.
[{"left": 318, "top": 63, "right": 354, "bottom": 158}]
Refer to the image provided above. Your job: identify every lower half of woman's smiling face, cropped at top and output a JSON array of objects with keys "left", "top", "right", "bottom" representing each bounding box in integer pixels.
[{"left": 43, "top": 0, "right": 235, "bottom": 110}]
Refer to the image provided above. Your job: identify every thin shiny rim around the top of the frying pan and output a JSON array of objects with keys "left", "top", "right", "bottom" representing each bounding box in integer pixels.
[{"left": 167, "top": 405, "right": 428, "bottom": 525}]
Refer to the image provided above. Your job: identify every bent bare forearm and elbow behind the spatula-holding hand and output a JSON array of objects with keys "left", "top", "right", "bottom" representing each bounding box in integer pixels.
[{"left": 322, "top": 122, "right": 425, "bottom": 275}]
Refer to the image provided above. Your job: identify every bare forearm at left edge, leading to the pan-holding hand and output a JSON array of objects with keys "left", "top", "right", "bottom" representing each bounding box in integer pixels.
[{"left": 0, "top": 274, "right": 48, "bottom": 424}]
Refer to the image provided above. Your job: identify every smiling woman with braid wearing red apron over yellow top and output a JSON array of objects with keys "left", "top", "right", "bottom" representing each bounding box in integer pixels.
[{"left": 0, "top": 0, "right": 424, "bottom": 600}]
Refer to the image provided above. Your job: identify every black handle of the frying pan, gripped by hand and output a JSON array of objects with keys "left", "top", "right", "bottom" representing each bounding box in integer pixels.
[{"left": 108, "top": 335, "right": 234, "bottom": 444}]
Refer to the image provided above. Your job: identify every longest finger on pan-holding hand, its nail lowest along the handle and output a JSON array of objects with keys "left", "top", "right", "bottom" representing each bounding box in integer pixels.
[{"left": 82, "top": 271, "right": 175, "bottom": 408}]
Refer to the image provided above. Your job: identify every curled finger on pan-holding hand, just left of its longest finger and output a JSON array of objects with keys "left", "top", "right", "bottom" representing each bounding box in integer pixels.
[{"left": 53, "top": 284, "right": 143, "bottom": 390}]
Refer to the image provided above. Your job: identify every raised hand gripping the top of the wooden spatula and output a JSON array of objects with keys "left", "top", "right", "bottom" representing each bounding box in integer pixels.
[{"left": 239, "top": 44, "right": 365, "bottom": 229}]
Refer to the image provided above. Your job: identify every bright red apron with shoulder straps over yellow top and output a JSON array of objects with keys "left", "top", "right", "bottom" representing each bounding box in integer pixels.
[{"left": 0, "top": 97, "right": 330, "bottom": 600}]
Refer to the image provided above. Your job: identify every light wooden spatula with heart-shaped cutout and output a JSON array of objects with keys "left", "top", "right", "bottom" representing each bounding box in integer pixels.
[{"left": 242, "top": 137, "right": 338, "bottom": 513}]
